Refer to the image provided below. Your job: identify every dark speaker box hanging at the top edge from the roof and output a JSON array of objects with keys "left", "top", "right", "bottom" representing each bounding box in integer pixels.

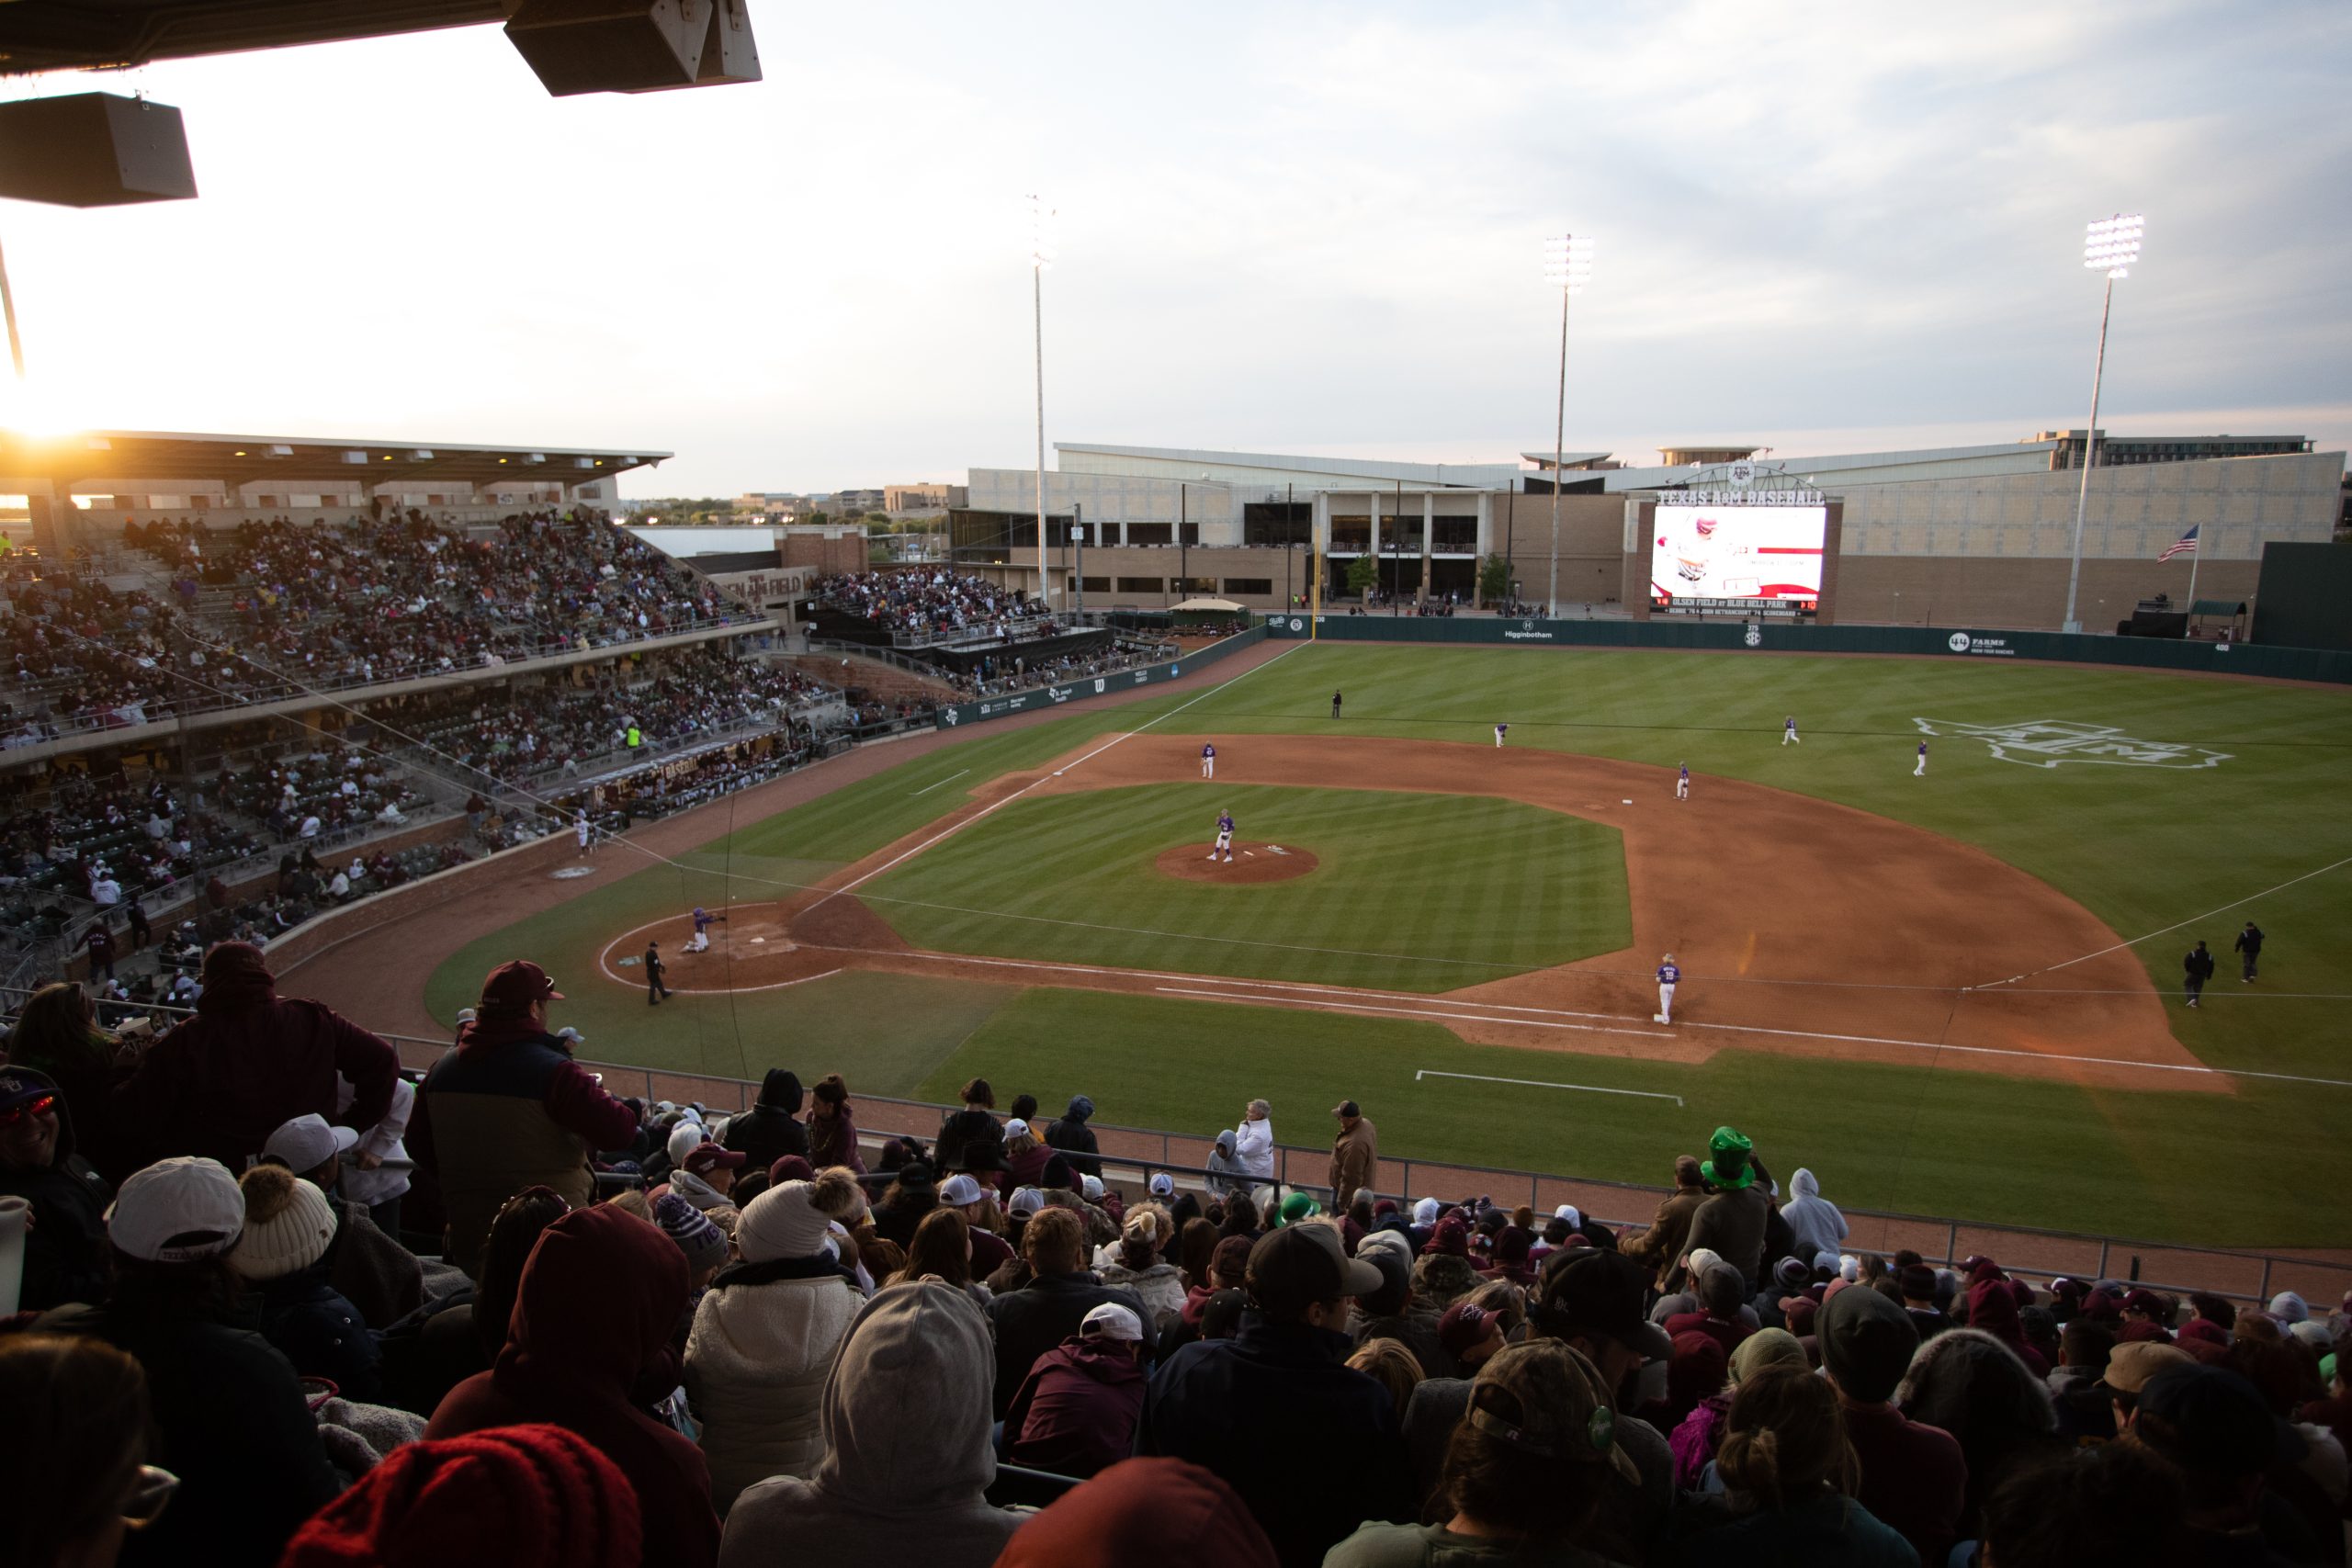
[{"left": 505, "top": 0, "right": 760, "bottom": 98}]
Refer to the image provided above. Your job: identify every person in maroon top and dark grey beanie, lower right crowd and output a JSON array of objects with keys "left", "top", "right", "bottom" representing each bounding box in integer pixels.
[{"left": 1820, "top": 1286, "right": 1969, "bottom": 1563}]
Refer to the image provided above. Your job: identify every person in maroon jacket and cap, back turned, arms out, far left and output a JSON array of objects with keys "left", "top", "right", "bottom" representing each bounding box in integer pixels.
[{"left": 115, "top": 942, "right": 400, "bottom": 1170}]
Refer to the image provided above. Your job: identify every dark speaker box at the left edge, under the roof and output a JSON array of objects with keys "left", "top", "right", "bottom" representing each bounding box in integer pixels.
[{"left": 0, "top": 92, "right": 195, "bottom": 207}]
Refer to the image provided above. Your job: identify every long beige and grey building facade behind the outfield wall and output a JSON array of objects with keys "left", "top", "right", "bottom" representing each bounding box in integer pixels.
[{"left": 950, "top": 430, "right": 2345, "bottom": 627}]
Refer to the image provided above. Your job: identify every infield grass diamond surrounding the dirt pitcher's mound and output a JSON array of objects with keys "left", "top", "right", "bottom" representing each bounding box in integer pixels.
[{"left": 858, "top": 783, "right": 1633, "bottom": 992}]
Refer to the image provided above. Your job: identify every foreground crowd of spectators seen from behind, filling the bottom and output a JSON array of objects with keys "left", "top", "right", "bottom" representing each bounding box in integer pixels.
[{"left": 0, "top": 982, "right": 2352, "bottom": 1568}]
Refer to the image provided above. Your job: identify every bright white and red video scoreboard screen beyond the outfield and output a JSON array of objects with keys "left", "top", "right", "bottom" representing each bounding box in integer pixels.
[{"left": 1649, "top": 503, "right": 1830, "bottom": 614}]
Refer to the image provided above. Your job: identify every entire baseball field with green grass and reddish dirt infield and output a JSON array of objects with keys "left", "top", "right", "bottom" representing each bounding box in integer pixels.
[{"left": 343, "top": 644, "right": 2352, "bottom": 1246}]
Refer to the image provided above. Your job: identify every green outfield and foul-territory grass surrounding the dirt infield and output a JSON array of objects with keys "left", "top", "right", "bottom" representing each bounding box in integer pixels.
[{"left": 430, "top": 644, "right": 2352, "bottom": 1246}]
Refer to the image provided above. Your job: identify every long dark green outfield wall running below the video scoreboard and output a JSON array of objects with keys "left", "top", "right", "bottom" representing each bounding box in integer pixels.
[{"left": 1265, "top": 614, "right": 2352, "bottom": 684}]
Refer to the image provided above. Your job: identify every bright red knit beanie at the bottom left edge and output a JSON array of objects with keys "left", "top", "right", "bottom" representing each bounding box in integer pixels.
[{"left": 277, "top": 1427, "right": 642, "bottom": 1568}]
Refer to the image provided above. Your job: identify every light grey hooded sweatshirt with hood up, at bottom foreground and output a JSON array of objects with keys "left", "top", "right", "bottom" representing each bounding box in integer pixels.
[{"left": 710, "top": 1279, "right": 1023, "bottom": 1568}]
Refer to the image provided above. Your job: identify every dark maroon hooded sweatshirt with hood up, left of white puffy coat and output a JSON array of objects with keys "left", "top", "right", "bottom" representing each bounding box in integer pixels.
[{"left": 425, "top": 1203, "right": 719, "bottom": 1568}]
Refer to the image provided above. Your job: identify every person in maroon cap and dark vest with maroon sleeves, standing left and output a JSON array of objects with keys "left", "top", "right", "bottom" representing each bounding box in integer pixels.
[{"left": 407, "top": 959, "right": 638, "bottom": 1274}]
